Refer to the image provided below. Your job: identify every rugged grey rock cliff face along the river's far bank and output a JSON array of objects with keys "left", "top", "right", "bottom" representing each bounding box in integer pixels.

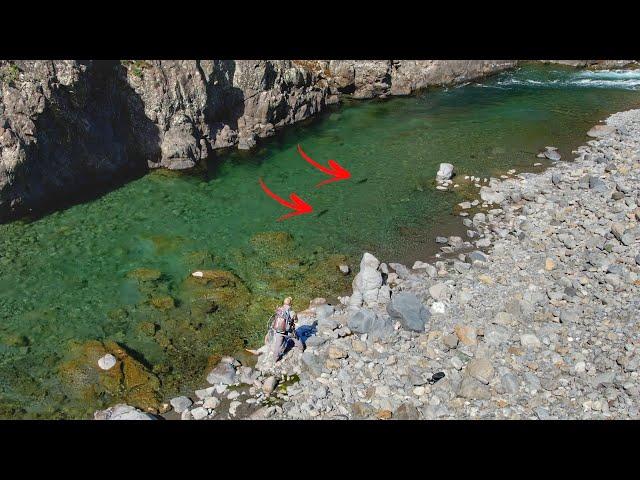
[{"left": 0, "top": 60, "right": 528, "bottom": 221}]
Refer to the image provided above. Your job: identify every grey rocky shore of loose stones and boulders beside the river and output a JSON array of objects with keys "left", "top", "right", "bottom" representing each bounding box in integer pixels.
[{"left": 95, "top": 110, "right": 640, "bottom": 420}]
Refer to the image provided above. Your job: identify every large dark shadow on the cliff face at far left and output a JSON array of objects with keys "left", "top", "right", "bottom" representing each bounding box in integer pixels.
[{"left": 0, "top": 61, "right": 160, "bottom": 222}]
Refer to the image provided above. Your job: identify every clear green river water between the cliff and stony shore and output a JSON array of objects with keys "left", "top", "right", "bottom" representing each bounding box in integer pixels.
[{"left": 0, "top": 66, "right": 640, "bottom": 418}]
